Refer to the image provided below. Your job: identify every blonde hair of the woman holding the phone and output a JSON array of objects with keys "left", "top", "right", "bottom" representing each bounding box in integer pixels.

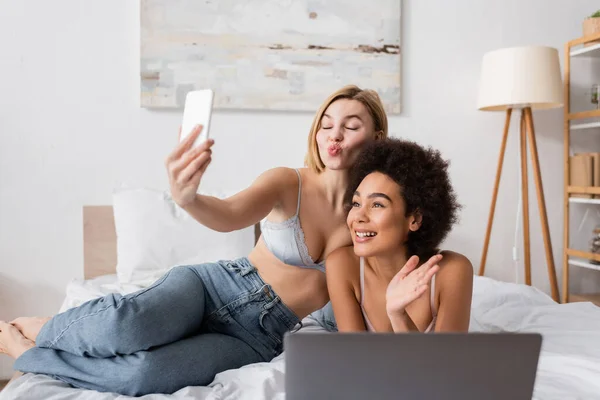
[{"left": 304, "top": 85, "right": 388, "bottom": 173}]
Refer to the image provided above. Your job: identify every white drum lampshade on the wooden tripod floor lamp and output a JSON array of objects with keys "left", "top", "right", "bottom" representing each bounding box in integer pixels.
[{"left": 477, "top": 46, "right": 563, "bottom": 111}]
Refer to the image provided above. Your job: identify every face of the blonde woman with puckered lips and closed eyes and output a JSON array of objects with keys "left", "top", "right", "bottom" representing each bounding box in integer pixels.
[{"left": 316, "top": 99, "right": 375, "bottom": 170}]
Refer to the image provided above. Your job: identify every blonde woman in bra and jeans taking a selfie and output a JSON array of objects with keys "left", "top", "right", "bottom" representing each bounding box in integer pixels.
[{"left": 0, "top": 86, "right": 387, "bottom": 396}]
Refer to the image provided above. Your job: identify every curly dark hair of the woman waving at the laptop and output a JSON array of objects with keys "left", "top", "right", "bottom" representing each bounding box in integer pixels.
[{"left": 344, "top": 138, "right": 462, "bottom": 260}]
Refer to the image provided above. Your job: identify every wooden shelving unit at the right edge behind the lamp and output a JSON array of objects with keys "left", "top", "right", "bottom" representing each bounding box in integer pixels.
[{"left": 561, "top": 34, "right": 600, "bottom": 306}]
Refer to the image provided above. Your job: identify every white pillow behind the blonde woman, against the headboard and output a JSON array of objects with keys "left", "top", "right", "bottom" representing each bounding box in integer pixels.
[{"left": 113, "top": 188, "right": 254, "bottom": 286}]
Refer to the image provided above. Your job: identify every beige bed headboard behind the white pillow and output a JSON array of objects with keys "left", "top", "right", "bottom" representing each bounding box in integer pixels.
[{"left": 83, "top": 206, "right": 260, "bottom": 279}]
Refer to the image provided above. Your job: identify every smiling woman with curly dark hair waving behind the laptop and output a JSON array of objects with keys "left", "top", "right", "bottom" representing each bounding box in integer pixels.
[{"left": 327, "top": 139, "right": 473, "bottom": 333}]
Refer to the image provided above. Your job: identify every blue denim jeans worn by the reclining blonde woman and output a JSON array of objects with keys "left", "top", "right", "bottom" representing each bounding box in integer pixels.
[{"left": 14, "top": 258, "right": 300, "bottom": 396}]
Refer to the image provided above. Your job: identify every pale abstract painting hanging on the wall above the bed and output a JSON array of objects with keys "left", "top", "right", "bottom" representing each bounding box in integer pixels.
[{"left": 140, "top": 0, "right": 401, "bottom": 114}]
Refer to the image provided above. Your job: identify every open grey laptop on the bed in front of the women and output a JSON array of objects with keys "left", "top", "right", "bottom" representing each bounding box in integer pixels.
[{"left": 284, "top": 332, "right": 542, "bottom": 400}]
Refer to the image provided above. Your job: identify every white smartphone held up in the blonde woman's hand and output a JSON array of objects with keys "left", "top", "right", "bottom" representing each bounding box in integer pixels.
[{"left": 180, "top": 89, "right": 214, "bottom": 147}]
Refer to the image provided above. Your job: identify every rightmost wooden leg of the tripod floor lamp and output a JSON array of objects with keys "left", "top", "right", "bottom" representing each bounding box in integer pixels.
[{"left": 524, "top": 107, "right": 560, "bottom": 302}]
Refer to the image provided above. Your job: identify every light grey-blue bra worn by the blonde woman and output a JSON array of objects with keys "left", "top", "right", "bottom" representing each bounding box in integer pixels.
[{"left": 260, "top": 170, "right": 325, "bottom": 272}]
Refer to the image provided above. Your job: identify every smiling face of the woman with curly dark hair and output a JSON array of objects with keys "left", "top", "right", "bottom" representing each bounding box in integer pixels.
[{"left": 346, "top": 172, "right": 420, "bottom": 257}]
